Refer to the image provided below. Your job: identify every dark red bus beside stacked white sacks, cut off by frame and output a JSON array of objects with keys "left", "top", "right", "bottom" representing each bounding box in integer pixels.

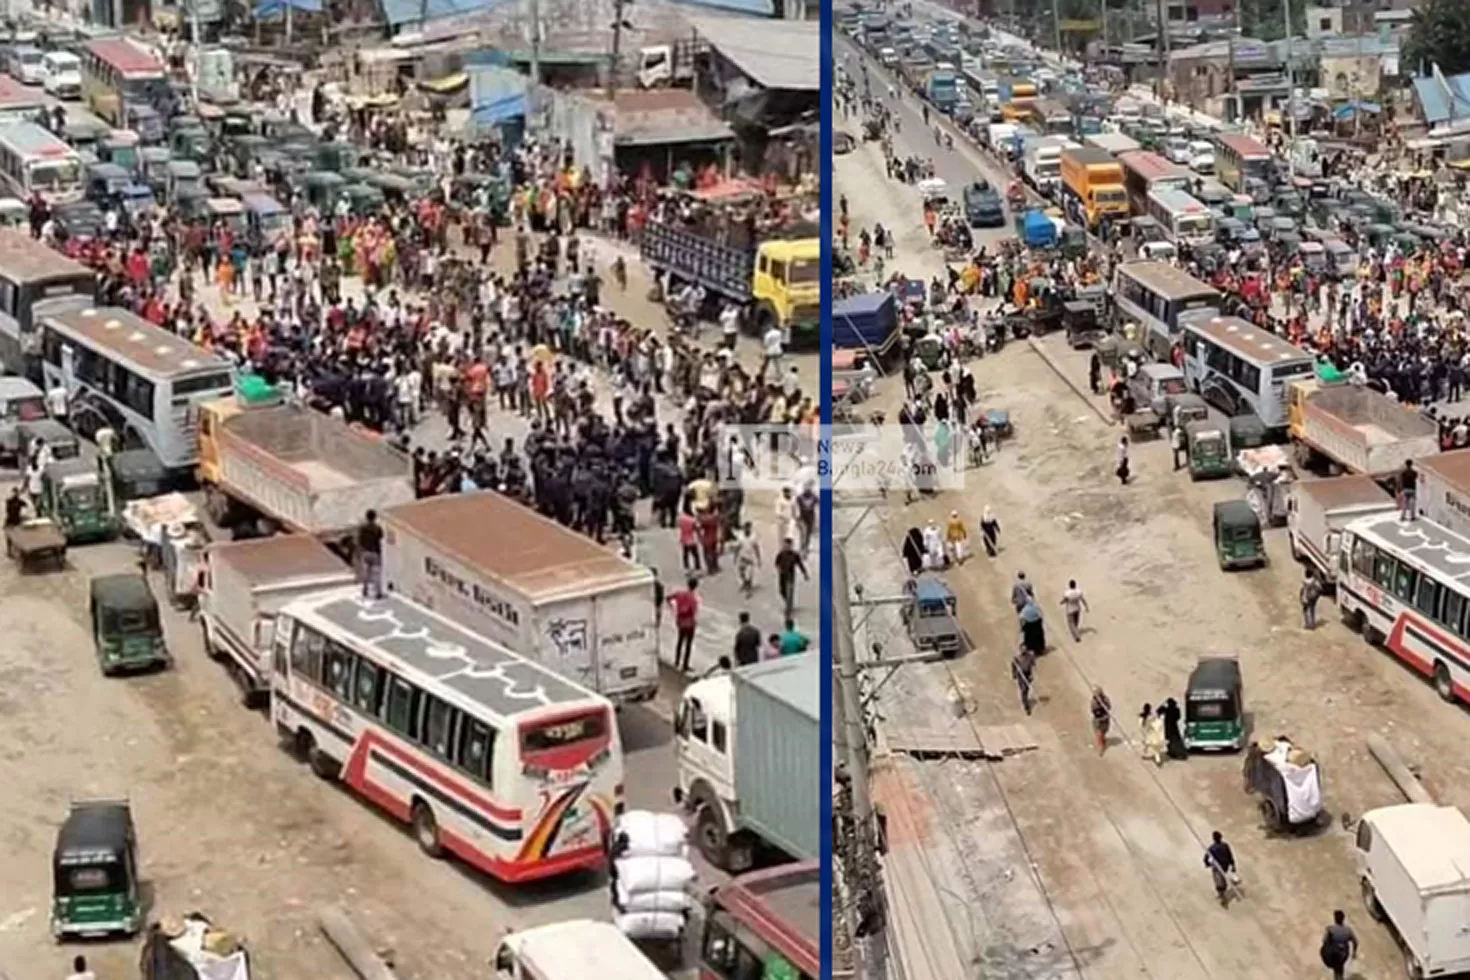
[{"left": 700, "top": 861, "right": 822, "bottom": 980}]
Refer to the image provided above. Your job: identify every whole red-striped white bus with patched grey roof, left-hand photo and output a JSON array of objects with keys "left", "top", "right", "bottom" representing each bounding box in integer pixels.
[{"left": 270, "top": 588, "right": 623, "bottom": 883}]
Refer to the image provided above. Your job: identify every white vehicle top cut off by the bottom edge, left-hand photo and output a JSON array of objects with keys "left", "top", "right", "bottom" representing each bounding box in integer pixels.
[{"left": 495, "top": 918, "right": 667, "bottom": 980}]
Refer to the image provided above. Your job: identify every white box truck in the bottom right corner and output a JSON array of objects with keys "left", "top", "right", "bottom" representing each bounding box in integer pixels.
[{"left": 1357, "top": 804, "right": 1470, "bottom": 977}]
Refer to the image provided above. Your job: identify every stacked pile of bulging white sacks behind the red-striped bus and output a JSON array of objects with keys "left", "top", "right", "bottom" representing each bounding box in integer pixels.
[{"left": 612, "top": 810, "right": 695, "bottom": 940}]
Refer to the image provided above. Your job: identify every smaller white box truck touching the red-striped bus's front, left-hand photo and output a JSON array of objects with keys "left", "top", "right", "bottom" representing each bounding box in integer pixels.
[{"left": 198, "top": 535, "right": 356, "bottom": 708}]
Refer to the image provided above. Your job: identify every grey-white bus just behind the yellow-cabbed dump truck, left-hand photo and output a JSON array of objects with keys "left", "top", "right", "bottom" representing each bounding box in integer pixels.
[{"left": 38, "top": 307, "right": 235, "bottom": 473}]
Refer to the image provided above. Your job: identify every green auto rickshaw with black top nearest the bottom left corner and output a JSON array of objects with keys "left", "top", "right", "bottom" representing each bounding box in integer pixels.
[{"left": 51, "top": 799, "right": 143, "bottom": 939}]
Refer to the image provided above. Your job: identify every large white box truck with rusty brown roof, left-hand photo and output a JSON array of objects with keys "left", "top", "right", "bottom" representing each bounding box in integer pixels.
[{"left": 381, "top": 491, "right": 659, "bottom": 704}]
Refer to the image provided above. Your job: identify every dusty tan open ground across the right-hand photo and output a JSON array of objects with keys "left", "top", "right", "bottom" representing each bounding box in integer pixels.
[{"left": 838, "top": 32, "right": 1470, "bottom": 980}]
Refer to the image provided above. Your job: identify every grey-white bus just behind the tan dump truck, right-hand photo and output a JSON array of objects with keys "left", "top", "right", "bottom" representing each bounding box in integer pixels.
[{"left": 1183, "top": 316, "right": 1316, "bottom": 435}]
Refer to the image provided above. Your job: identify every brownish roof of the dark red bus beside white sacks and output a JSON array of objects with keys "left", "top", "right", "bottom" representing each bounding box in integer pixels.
[{"left": 713, "top": 861, "right": 822, "bottom": 976}]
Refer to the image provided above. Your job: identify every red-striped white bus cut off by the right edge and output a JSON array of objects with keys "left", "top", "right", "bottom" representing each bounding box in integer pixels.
[{"left": 1338, "top": 513, "right": 1470, "bottom": 701}]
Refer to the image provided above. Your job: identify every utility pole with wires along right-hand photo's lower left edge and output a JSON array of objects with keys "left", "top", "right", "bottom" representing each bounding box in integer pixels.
[{"left": 832, "top": 544, "right": 888, "bottom": 980}]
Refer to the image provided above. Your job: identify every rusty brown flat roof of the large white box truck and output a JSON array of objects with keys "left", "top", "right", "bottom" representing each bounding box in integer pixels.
[{"left": 382, "top": 491, "right": 653, "bottom": 601}]
